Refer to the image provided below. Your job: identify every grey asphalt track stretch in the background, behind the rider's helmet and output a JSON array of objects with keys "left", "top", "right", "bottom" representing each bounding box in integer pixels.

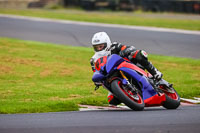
[{"left": 0, "top": 15, "right": 200, "bottom": 58}]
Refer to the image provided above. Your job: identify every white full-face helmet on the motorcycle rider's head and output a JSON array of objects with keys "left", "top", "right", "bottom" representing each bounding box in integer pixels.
[{"left": 92, "top": 32, "right": 112, "bottom": 53}]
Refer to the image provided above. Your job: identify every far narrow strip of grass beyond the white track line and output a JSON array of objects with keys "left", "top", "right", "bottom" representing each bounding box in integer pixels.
[{"left": 0, "top": 8, "right": 200, "bottom": 30}]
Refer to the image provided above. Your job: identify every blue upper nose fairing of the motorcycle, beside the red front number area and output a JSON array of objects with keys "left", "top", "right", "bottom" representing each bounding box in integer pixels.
[{"left": 106, "top": 54, "right": 124, "bottom": 74}]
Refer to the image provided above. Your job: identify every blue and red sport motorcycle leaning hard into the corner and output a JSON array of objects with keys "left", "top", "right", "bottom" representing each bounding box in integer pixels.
[{"left": 92, "top": 54, "right": 180, "bottom": 111}]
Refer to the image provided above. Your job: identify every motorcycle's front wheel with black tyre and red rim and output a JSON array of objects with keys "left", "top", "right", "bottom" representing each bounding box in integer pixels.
[{"left": 111, "top": 79, "right": 144, "bottom": 111}]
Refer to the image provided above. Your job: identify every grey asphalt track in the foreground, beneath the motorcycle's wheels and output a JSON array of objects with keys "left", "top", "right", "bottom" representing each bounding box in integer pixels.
[{"left": 0, "top": 105, "right": 200, "bottom": 133}]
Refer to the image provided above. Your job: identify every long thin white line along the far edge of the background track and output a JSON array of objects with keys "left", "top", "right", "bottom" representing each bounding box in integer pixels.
[{"left": 0, "top": 14, "right": 200, "bottom": 35}]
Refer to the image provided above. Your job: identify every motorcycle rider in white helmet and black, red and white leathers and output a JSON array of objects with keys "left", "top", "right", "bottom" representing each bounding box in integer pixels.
[{"left": 90, "top": 32, "right": 162, "bottom": 105}]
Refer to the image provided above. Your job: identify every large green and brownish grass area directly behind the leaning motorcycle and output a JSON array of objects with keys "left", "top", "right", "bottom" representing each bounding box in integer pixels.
[{"left": 0, "top": 38, "right": 200, "bottom": 113}]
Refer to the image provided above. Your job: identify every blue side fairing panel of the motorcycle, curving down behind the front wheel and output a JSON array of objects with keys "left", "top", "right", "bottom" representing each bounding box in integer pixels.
[{"left": 119, "top": 67, "right": 157, "bottom": 100}]
